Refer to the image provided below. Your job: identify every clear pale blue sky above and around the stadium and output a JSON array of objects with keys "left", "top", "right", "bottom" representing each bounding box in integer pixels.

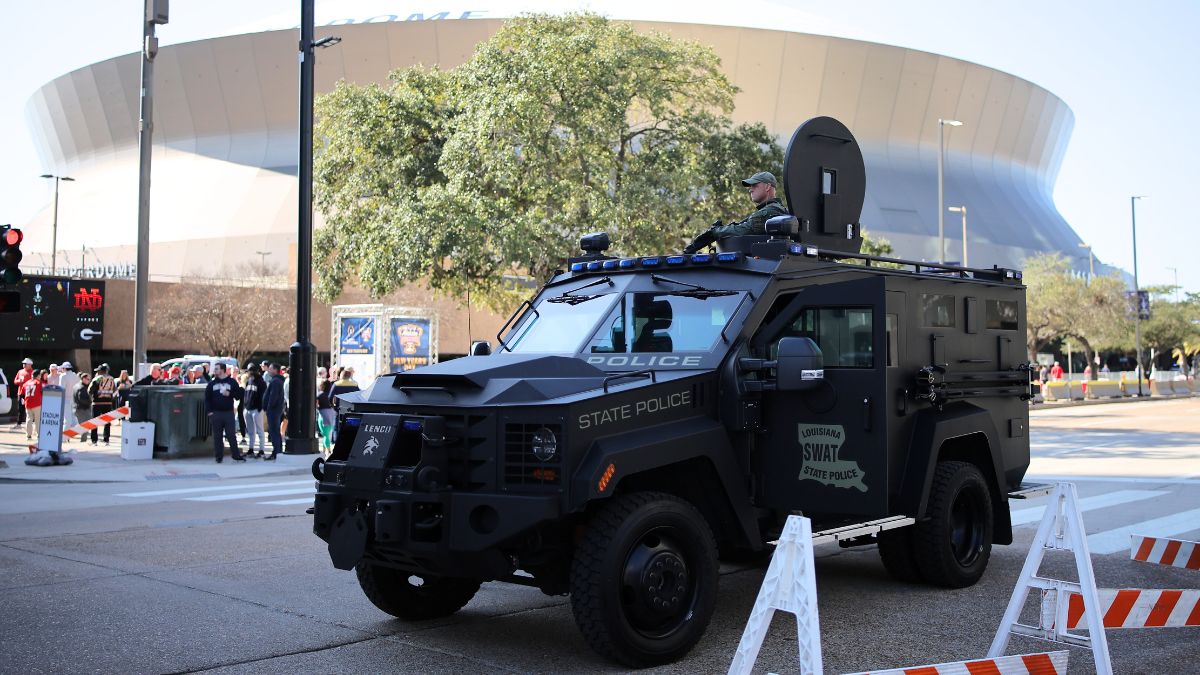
[{"left": 0, "top": 0, "right": 1200, "bottom": 292}]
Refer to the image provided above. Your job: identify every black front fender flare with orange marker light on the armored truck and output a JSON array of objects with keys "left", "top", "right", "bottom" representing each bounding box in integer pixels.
[{"left": 570, "top": 417, "right": 762, "bottom": 545}]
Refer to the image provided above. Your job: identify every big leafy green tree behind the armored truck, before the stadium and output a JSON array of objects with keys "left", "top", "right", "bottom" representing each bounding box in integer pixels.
[{"left": 314, "top": 14, "right": 782, "bottom": 306}]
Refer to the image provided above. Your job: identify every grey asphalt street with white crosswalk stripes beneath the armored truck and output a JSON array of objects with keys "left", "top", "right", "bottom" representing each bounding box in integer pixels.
[{"left": 0, "top": 399, "right": 1200, "bottom": 674}]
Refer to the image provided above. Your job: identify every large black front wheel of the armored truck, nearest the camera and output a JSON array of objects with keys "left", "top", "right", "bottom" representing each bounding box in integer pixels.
[{"left": 571, "top": 492, "right": 718, "bottom": 668}]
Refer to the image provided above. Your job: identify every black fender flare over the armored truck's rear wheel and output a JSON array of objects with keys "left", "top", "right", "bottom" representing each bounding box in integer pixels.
[{"left": 893, "top": 402, "right": 1013, "bottom": 544}]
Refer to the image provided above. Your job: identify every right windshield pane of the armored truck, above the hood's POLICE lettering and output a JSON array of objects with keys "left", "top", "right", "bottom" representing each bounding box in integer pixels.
[{"left": 584, "top": 291, "right": 745, "bottom": 354}]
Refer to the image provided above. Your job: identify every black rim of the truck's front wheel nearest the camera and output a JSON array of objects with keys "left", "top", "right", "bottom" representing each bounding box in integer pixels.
[{"left": 620, "top": 527, "right": 696, "bottom": 639}]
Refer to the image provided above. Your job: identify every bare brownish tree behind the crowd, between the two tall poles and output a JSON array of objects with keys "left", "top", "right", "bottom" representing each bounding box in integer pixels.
[{"left": 149, "top": 263, "right": 295, "bottom": 363}]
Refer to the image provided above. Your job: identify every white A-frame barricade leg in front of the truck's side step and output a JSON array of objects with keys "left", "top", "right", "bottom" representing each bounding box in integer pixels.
[{"left": 730, "top": 515, "right": 824, "bottom": 675}]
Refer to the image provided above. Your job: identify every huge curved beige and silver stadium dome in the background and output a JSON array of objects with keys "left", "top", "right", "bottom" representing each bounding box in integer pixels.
[{"left": 26, "top": 1, "right": 1086, "bottom": 279}]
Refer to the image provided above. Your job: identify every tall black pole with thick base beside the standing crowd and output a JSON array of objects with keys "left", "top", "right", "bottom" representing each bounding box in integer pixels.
[{"left": 290, "top": 0, "right": 341, "bottom": 454}]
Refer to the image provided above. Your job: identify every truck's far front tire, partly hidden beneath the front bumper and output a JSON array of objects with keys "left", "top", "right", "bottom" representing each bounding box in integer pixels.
[{"left": 354, "top": 562, "right": 479, "bottom": 621}]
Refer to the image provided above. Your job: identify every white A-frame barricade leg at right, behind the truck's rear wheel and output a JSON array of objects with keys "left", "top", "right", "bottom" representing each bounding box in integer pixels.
[{"left": 988, "top": 483, "right": 1112, "bottom": 675}]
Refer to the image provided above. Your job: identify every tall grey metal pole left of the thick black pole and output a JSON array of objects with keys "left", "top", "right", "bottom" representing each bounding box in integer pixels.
[{"left": 133, "top": 0, "right": 168, "bottom": 377}]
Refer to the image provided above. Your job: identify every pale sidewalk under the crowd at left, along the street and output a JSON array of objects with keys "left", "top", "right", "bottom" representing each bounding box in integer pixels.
[{"left": 0, "top": 422, "right": 318, "bottom": 483}]
